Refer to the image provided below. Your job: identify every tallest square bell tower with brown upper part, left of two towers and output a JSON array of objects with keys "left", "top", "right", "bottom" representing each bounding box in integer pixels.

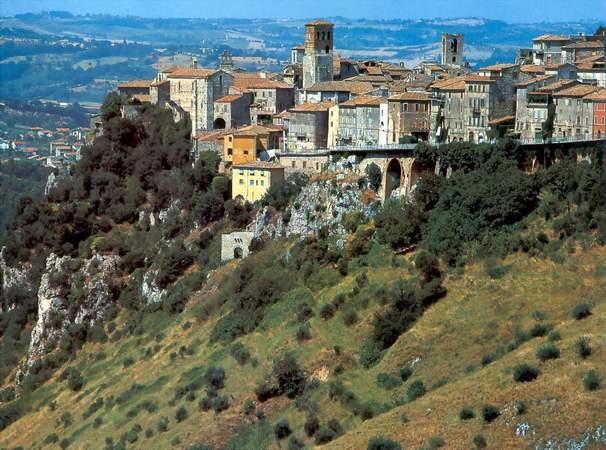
[{"left": 303, "top": 20, "right": 334, "bottom": 89}]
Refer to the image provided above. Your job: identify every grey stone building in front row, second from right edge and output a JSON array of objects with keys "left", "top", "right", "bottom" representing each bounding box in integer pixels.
[{"left": 553, "top": 83, "right": 598, "bottom": 139}]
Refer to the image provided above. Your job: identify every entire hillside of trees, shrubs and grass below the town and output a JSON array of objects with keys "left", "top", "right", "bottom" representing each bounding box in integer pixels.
[{"left": 0, "top": 93, "right": 606, "bottom": 450}]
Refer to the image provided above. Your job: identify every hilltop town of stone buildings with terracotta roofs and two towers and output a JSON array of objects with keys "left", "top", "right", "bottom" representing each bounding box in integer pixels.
[{"left": 118, "top": 20, "right": 606, "bottom": 201}]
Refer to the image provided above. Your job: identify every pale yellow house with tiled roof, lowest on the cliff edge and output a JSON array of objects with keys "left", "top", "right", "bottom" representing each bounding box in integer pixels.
[{"left": 231, "top": 161, "right": 284, "bottom": 203}]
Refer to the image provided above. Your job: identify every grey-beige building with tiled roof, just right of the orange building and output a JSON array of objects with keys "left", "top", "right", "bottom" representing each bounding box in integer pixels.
[{"left": 286, "top": 102, "right": 334, "bottom": 151}]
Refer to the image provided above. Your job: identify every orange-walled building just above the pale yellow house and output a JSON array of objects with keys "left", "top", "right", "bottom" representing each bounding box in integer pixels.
[{"left": 223, "top": 125, "right": 283, "bottom": 165}]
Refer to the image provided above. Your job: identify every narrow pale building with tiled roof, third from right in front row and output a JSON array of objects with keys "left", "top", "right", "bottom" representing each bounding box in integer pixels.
[{"left": 514, "top": 75, "right": 556, "bottom": 142}]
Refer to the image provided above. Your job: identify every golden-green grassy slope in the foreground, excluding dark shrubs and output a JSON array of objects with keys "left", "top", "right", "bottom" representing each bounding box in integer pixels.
[{"left": 0, "top": 239, "right": 606, "bottom": 449}]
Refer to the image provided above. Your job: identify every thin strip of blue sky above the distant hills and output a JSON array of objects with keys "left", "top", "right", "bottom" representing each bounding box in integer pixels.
[{"left": 0, "top": 0, "right": 606, "bottom": 22}]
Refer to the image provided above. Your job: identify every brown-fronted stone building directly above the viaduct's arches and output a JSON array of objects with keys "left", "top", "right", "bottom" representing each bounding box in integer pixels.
[{"left": 387, "top": 92, "right": 431, "bottom": 144}]
